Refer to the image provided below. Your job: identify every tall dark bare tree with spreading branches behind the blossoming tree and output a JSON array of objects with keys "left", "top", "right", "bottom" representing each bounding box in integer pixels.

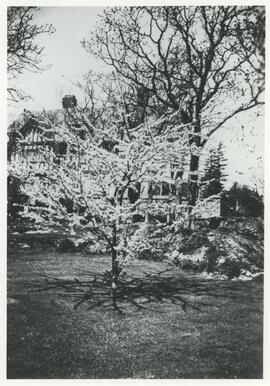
[{"left": 83, "top": 6, "right": 265, "bottom": 204}]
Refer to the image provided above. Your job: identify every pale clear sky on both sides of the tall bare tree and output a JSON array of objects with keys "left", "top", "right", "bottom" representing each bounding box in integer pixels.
[{"left": 8, "top": 7, "right": 264, "bottom": 191}]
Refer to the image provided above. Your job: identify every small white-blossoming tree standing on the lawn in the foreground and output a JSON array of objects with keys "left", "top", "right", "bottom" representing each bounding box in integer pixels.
[{"left": 10, "top": 107, "right": 192, "bottom": 302}]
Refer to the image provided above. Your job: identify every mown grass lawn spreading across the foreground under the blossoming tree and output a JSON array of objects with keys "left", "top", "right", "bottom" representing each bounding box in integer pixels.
[{"left": 7, "top": 243, "right": 263, "bottom": 379}]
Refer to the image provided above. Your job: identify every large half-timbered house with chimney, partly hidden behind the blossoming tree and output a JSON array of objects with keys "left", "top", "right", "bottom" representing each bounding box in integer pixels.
[{"left": 8, "top": 95, "right": 224, "bottom": 225}]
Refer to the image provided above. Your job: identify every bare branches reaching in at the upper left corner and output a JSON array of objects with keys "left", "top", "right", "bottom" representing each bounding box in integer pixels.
[{"left": 7, "top": 7, "right": 54, "bottom": 102}]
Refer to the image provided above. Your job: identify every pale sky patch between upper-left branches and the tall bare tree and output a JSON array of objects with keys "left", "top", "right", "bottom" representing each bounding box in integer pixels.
[{"left": 10, "top": 7, "right": 106, "bottom": 115}]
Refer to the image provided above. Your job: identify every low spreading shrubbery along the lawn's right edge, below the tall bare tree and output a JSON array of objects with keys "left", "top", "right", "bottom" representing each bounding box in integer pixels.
[{"left": 130, "top": 219, "right": 263, "bottom": 279}]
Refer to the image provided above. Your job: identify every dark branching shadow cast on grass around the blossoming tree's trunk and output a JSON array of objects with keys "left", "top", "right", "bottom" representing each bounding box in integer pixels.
[{"left": 26, "top": 269, "right": 247, "bottom": 314}]
